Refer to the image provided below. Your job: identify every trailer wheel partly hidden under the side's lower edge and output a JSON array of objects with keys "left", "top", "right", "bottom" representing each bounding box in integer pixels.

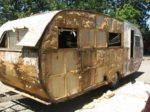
[{"left": 110, "top": 73, "right": 120, "bottom": 89}]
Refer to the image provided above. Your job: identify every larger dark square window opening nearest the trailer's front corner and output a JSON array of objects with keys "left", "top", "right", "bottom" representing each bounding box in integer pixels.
[{"left": 58, "top": 28, "right": 77, "bottom": 48}]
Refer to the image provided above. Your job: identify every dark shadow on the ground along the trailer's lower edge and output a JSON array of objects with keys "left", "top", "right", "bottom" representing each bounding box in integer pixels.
[{"left": 3, "top": 72, "right": 143, "bottom": 112}]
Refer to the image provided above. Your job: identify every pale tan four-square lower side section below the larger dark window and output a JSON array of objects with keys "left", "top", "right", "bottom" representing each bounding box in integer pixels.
[{"left": 42, "top": 49, "right": 80, "bottom": 99}]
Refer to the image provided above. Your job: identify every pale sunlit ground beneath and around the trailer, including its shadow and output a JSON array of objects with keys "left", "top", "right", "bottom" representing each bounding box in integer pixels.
[{"left": 0, "top": 56, "right": 150, "bottom": 112}]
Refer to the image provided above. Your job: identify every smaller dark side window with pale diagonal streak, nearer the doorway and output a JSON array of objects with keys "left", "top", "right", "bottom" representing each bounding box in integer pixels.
[{"left": 108, "top": 32, "right": 121, "bottom": 46}]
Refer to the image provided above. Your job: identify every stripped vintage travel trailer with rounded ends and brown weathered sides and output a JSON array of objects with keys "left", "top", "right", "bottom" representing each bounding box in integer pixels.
[{"left": 0, "top": 10, "right": 143, "bottom": 104}]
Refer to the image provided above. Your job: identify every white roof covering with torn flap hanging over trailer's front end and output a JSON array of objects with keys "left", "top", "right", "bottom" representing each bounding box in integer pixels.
[{"left": 0, "top": 11, "right": 60, "bottom": 47}]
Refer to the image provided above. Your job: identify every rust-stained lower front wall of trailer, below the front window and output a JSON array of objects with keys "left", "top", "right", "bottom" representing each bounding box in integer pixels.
[{"left": 0, "top": 50, "right": 46, "bottom": 99}]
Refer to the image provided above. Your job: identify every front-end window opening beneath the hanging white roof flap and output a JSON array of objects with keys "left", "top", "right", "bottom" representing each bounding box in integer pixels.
[{"left": 0, "top": 29, "right": 27, "bottom": 49}]
